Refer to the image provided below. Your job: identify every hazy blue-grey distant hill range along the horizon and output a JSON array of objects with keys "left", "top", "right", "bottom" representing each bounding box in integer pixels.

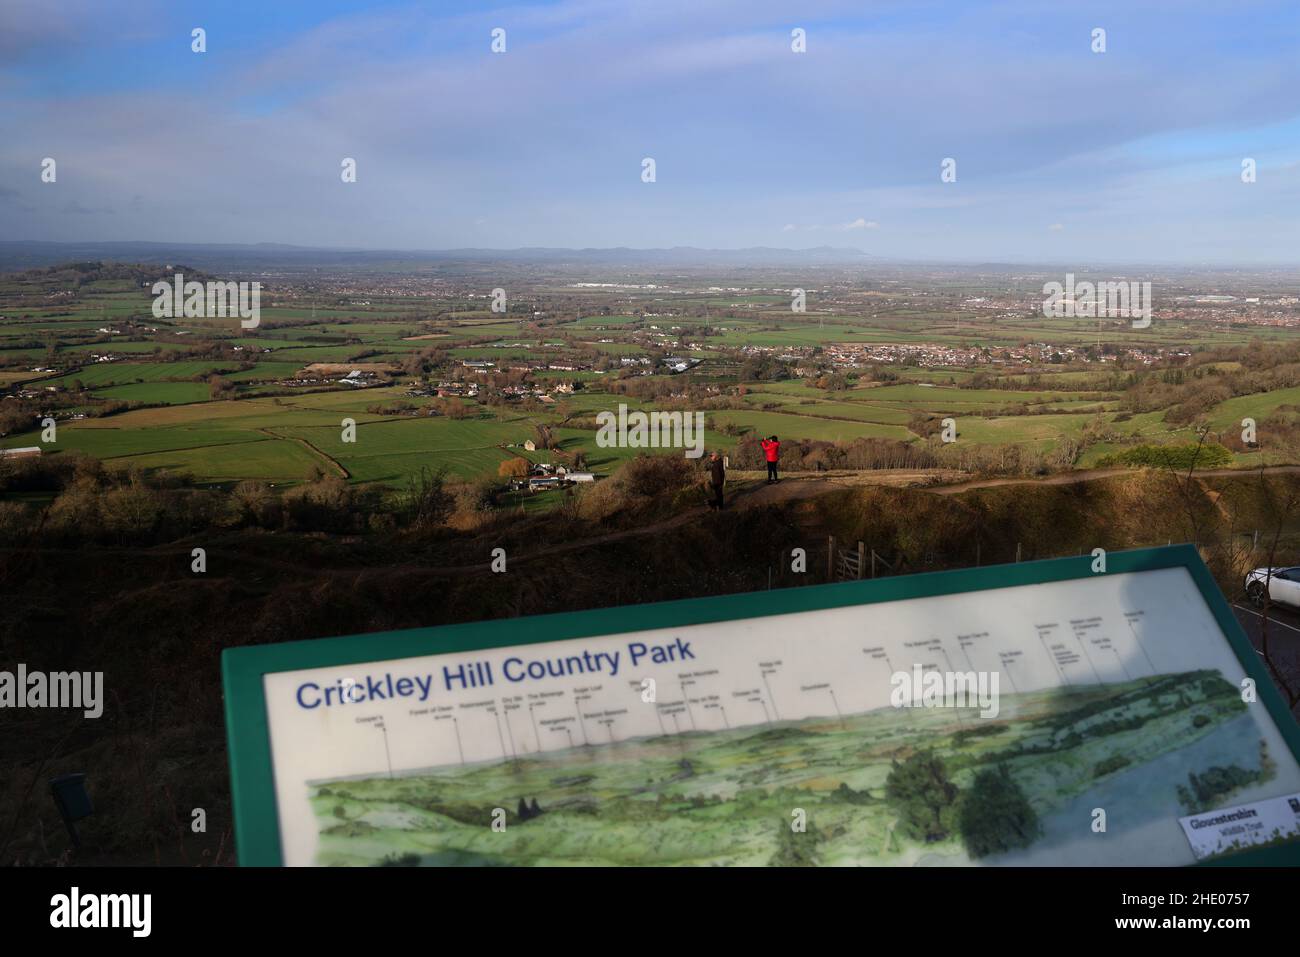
[{"left": 0, "top": 242, "right": 875, "bottom": 272}]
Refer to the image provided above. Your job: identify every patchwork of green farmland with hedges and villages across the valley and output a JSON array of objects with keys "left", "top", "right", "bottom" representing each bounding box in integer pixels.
[{"left": 0, "top": 264, "right": 1300, "bottom": 501}]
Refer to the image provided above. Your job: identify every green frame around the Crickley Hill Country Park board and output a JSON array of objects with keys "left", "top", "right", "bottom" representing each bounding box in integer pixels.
[{"left": 221, "top": 545, "right": 1300, "bottom": 867}]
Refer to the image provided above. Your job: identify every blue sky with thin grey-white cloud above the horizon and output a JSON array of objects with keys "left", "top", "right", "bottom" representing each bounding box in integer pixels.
[{"left": 0, "top": 0, "right": 1300, "bottom": 265}]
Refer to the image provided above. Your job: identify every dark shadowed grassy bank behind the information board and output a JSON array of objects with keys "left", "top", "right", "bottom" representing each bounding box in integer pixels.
[{"left": 0, "top": 472, "right": 1300, "bottom": 865}]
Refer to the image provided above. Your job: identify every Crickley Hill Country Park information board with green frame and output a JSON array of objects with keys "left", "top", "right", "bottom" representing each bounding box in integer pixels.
[{"left": 224, "top": 546, "right": 1300, "bottom": 866}]
